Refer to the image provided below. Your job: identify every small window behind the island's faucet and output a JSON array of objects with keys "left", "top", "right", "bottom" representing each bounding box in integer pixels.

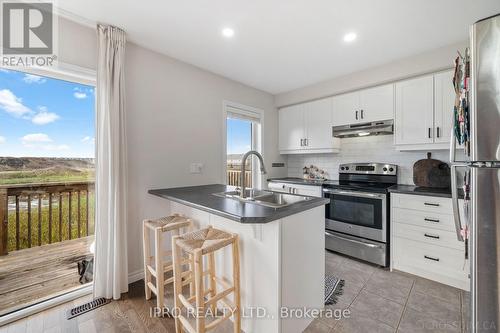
[{"left": 225, "top": 103, "right": 262, "bottom": 187}]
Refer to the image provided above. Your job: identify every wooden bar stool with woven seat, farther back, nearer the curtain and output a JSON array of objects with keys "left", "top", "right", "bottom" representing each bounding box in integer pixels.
[{"left": 143, "top": 214, "right": 194, "bottom": 309}]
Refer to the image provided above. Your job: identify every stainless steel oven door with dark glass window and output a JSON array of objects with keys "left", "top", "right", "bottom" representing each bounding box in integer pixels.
[{"left": 323, "top": 188, "right": 387, "bottom": 243}]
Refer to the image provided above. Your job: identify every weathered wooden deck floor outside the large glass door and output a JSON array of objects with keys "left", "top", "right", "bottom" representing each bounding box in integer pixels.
[{"left": 0, "top": 236, "right": 94, "bottom": 315}]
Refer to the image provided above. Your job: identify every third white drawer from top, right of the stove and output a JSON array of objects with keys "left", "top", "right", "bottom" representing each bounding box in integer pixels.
[{"left": 393, "top": 223, "right": 465, "bottom": 250}]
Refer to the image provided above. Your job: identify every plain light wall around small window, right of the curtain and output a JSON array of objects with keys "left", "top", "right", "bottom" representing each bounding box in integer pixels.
[{"left": 125, "top": 44, "right": 286, "bottom": 272}]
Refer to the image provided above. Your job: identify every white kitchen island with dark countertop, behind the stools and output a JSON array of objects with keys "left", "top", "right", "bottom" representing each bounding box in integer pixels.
[{"left": 149, "top": 184, "right": 328, "bottom": 333}]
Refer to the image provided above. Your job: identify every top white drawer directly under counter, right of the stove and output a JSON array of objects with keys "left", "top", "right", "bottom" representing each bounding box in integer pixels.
[{"left": 391, "top": 193, "right": 453, "bottom": 215}]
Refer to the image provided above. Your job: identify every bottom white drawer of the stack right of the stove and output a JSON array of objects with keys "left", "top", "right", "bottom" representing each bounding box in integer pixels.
[{"left": 393, "top": 237, "right": 466, "bottom": 275}]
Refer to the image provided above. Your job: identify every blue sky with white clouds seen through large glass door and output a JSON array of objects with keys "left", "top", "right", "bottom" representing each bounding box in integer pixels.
[{"left": 0, "top": 69, "right": 95, "bottom": 157}]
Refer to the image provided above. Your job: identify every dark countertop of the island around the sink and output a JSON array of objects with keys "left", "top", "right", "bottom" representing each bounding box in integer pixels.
[{"left": 148, "top": 184, "right": 329, "bottom": 223}]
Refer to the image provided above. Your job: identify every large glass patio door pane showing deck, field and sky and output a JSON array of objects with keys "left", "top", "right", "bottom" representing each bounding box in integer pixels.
[{"left": 0, "top": 68, "right": 95, "bottom": 316}]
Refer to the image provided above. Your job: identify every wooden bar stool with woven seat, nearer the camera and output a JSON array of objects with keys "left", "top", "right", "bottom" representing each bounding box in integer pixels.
[{"left": 172, "top": 226, "right": 241, "bottom": 333}]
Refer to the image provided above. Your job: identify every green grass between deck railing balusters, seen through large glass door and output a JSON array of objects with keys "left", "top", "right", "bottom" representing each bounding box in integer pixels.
[{"left": 8, "top": 193, "right": 95, "bottom": 251}]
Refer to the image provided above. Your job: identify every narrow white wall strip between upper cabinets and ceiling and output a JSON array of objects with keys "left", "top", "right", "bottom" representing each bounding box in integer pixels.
[{"left": 275, "top": 41, "right": 467, "bottom": 107}]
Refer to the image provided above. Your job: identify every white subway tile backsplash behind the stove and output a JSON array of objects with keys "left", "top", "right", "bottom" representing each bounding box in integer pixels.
[{"left": 287, "top": 135, "right": 448, "bottom": 185}]
